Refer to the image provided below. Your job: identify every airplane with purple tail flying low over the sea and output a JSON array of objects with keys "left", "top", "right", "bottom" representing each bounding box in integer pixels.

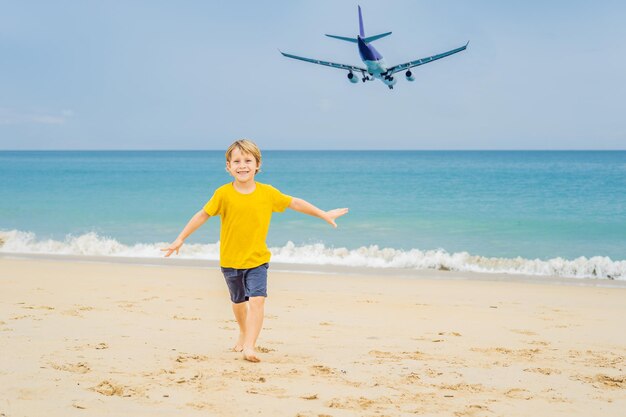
[{"left": 279, "top": 6, "right": 469, "bottom": 90}]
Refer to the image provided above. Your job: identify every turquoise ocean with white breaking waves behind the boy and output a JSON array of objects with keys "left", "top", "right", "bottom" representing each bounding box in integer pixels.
[{"left": 0, "top": 151, "right": 626, "bottom": 280}]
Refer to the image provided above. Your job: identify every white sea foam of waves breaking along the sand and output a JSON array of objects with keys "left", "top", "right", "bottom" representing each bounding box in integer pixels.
[{"left": 0, "top": 230, "right": 626, "bottom": 280}]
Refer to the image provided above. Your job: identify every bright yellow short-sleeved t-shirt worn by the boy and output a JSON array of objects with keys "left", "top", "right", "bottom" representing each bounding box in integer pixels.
[{"left": 204, "top": 182, "right": 292, "bottom": 269}]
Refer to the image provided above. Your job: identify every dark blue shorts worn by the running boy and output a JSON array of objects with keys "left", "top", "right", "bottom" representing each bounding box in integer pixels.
[{"left": 222, "top": 263, "right": 270, "bottom": 304}]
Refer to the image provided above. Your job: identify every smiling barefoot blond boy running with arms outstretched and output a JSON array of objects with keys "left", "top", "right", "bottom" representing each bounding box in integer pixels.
[{"left": 162, "top": 139, "right": 348, "bottom": 362}]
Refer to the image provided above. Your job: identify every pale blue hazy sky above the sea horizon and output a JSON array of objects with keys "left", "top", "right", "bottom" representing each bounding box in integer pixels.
[{"left": 0, "top": 0, "right": 626, "bottom": 150}]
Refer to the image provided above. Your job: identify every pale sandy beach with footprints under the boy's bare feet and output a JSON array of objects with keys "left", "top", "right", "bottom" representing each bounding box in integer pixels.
[{"left": 0, "top": 258, "right": 626, "bottom": 417}]
